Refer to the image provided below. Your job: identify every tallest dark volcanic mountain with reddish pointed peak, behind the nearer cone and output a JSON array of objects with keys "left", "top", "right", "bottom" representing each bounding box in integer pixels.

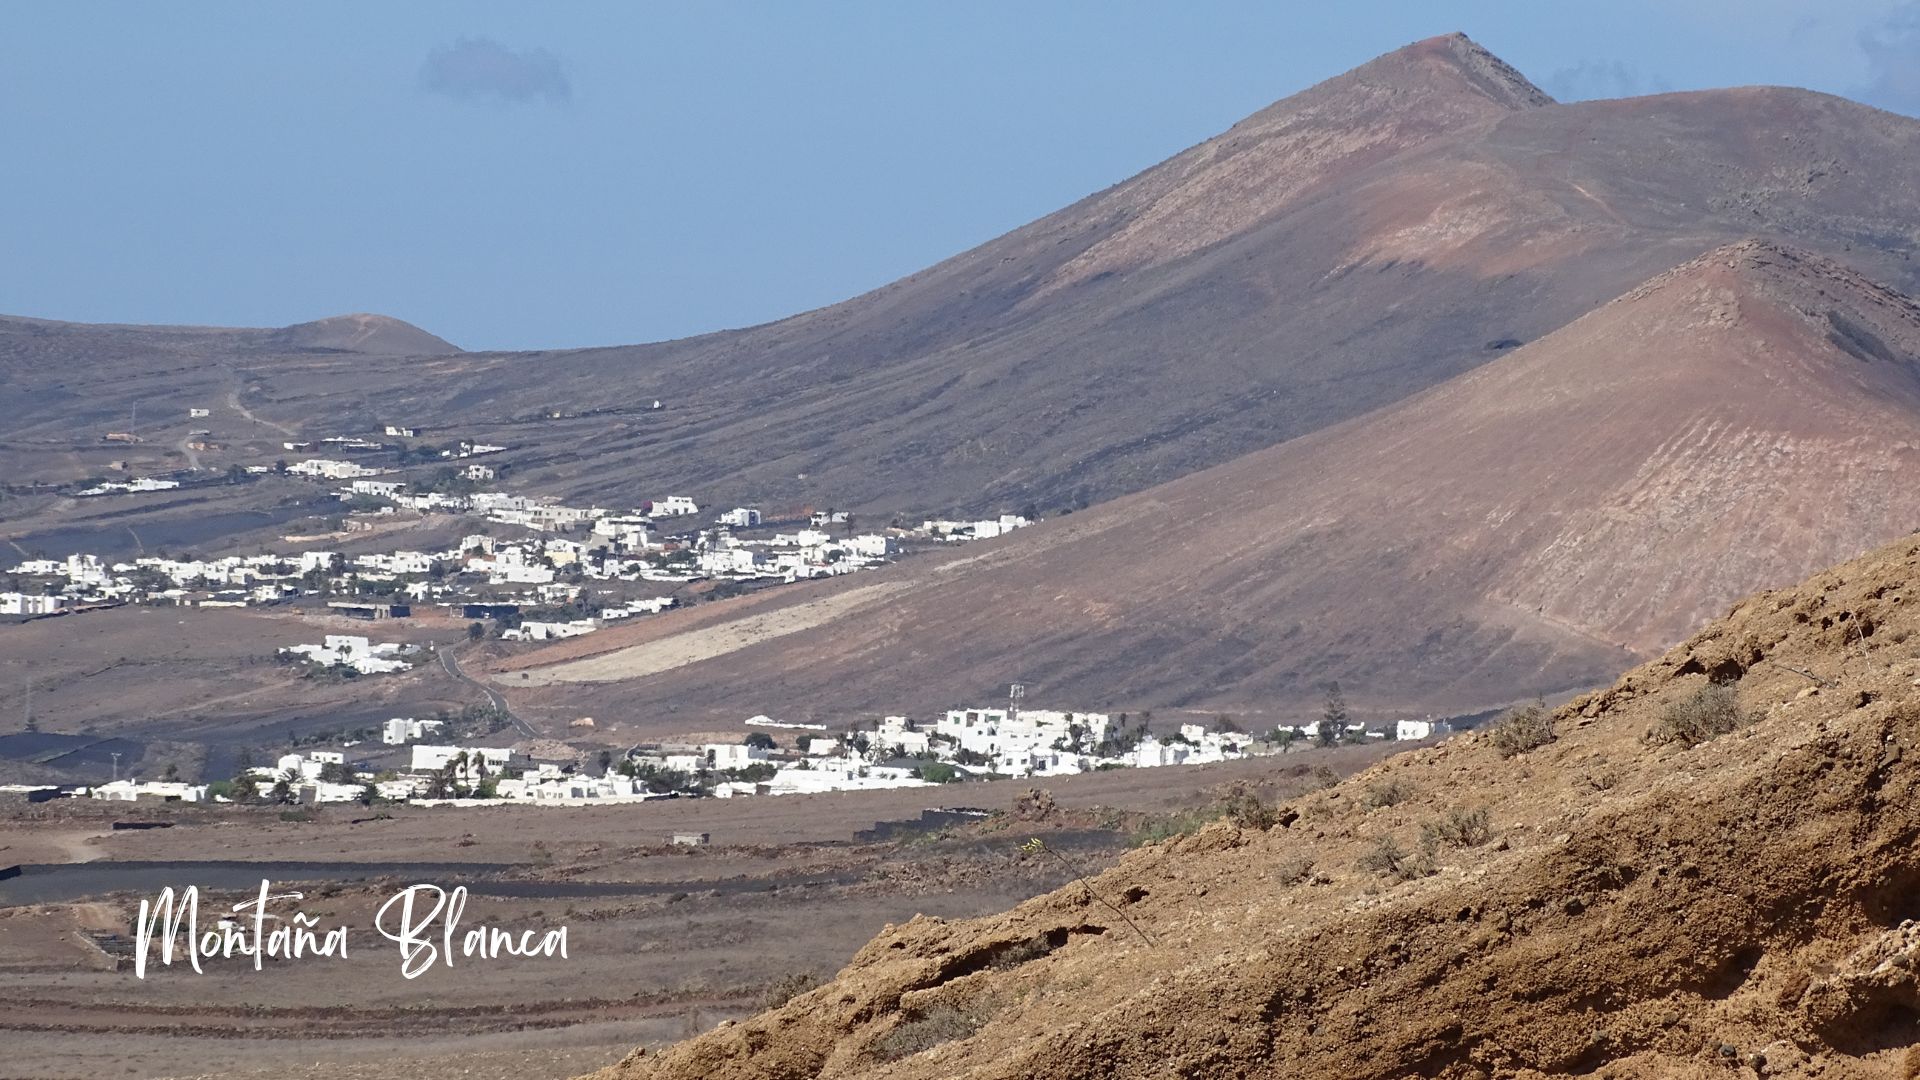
[{"left": 11, "top": 35, "right": 1920, "bottom": 513}]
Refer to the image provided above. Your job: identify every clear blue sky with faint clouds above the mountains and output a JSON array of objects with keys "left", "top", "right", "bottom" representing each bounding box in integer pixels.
[{"left": 0, "top": 0, "right": 1920, "bottom": 348}]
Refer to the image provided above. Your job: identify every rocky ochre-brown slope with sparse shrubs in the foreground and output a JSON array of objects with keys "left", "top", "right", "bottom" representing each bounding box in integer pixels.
[{"left": 601, "top": 538, "right": 1920, "bottom": 1080}]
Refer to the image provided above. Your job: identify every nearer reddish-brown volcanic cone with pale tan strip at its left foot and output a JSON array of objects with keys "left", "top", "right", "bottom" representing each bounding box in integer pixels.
[{"left": 505, "top": 242, "right": 1920, "bottom": 719}]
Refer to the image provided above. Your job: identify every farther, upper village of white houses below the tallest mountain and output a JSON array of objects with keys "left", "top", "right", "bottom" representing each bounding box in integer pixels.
[{"left": 0, "top": 478, "right": 1029, "bottom": 657}]
